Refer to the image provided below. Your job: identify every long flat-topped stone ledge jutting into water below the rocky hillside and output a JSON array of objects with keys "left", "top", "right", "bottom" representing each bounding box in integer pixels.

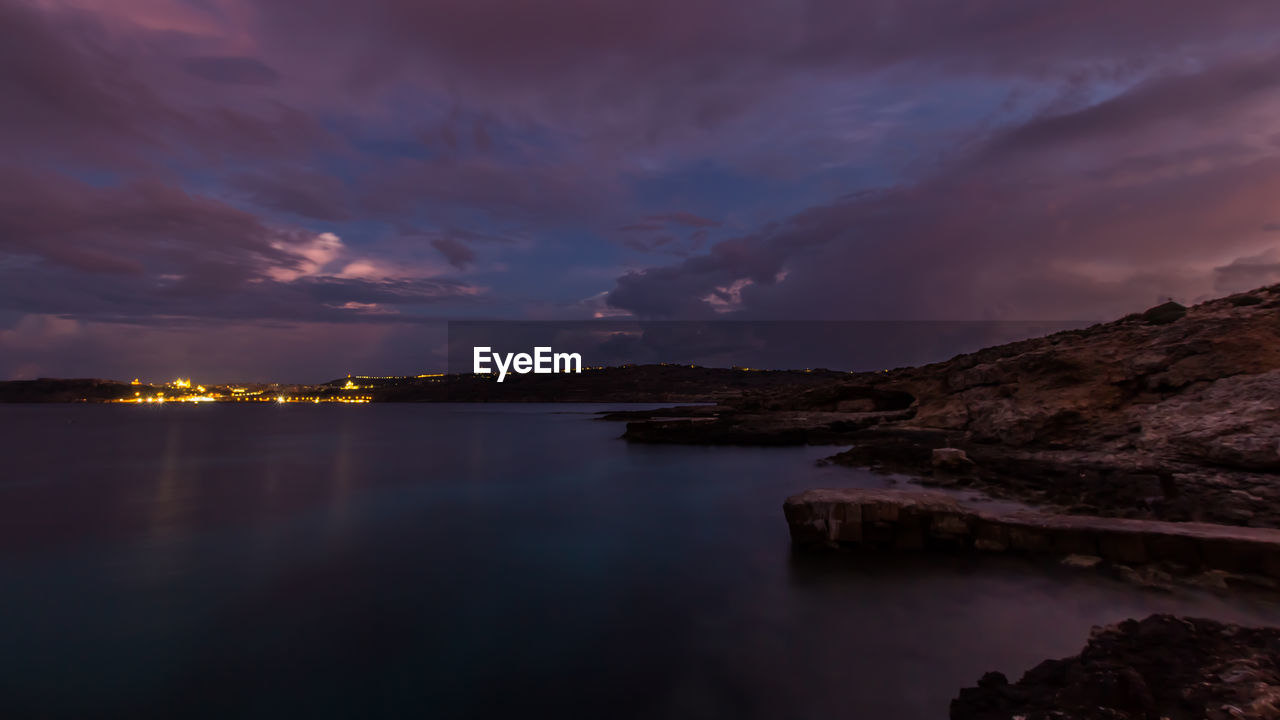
[{"left": 783, "top": 488, "right": 1280, "bottom": 588}]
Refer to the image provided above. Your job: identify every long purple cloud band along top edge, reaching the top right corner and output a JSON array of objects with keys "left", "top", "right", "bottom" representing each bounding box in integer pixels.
[{"left": 247, "top": 0, "right": 1280, "bottom": 143}]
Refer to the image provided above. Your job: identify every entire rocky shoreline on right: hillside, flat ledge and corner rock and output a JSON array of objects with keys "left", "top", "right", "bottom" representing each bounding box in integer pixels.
[{"left": 613, "top": 286, "right": 1280, "bottom": 720}]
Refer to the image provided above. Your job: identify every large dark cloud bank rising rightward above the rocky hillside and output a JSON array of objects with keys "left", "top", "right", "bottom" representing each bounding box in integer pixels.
[{"left": 608, "top": 59, "right": 1280, "bottom": 319}]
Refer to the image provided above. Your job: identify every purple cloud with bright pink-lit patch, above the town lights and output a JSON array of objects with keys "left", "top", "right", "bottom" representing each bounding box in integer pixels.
[{"left": 0, "top": 168, "right": 477, "bottom": 323}]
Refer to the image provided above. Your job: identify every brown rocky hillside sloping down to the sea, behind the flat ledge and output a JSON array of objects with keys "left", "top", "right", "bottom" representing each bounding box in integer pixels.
[{"left": 623, "top": 286, "right": 1280, "bottom": 528}]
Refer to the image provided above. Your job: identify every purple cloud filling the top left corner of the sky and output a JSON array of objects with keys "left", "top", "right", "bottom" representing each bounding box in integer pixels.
[{"left": 0, "top": 0, "right": 333, "bottom": 170}]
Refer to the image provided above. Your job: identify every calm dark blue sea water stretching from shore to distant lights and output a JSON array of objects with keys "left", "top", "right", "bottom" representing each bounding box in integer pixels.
[{"left": 0, "top": 405, "right": 1280, "bottom": 719}]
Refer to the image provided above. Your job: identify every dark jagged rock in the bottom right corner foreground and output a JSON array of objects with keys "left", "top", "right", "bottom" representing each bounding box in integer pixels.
[{"left": 951, "top": 615, "right": 1280, "bottom": 720}]
